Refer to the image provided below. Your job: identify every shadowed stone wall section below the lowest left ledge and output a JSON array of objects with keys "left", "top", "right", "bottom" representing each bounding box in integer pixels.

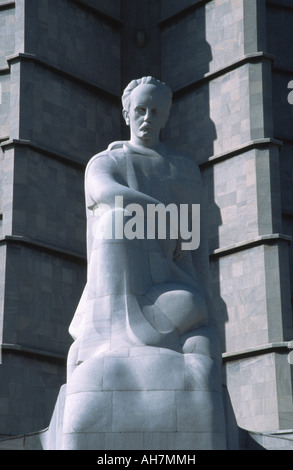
[{"left": 0, "top": 348, "right": 65, "bottom": 436}]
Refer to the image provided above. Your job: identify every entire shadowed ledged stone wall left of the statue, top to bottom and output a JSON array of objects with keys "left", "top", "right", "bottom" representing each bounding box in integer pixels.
[{"left": 0, "top": 0, "right": 122, "bottom": 435}]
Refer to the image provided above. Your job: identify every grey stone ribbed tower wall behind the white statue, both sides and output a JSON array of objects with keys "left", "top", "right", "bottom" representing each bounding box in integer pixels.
[{"left": 0, "top": 0, "right": 293, "bottom": 448}]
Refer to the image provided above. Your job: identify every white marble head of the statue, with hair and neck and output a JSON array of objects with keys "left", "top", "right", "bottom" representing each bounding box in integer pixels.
[{"left": 122, "top": 77, "right": 172, "bottom": 147}]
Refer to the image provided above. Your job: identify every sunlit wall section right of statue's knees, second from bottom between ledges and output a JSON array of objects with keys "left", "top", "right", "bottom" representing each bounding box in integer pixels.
[{"left": 211, "top": 243, "right": 292, "bottom": 353}]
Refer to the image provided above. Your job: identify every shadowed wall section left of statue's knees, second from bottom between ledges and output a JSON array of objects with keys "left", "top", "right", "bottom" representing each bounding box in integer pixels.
[{"left": 3, "top": 245, "right": 85, "bottom": 355}]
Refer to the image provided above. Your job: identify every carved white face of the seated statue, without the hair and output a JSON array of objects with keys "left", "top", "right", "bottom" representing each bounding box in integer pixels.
[{"left": 124, "top": 84, "right": 169, "bottom": 147}]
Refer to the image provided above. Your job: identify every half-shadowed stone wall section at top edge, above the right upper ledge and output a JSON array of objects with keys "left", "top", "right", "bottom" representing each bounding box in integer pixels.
[{"left": 162, "top": 0, "right": 244, "bottom": 89}]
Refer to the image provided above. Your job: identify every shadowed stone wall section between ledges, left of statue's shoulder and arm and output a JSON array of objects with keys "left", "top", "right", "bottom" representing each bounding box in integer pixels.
[{"left": 13, "top": 147, "right": 86, "bottom": 252}]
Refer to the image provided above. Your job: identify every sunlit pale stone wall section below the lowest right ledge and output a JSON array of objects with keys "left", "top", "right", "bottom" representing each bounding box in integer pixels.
[{"left": 227, "top": 353, "right": 292, "bottom": 436}]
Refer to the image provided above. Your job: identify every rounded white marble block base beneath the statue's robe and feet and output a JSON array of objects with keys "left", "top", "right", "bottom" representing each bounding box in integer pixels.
[{"left": 43, "top": 346, "right": 226, "bottom": 450}]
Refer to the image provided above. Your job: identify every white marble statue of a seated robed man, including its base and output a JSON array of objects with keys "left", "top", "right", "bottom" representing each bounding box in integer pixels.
[{"left": 43, "top": 77, "right": 225, "bottom": 450}]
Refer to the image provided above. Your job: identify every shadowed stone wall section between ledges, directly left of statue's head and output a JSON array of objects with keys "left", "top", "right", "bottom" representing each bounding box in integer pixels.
[{"left": 16, "top": 62, "right": 121, "bottom": 164}]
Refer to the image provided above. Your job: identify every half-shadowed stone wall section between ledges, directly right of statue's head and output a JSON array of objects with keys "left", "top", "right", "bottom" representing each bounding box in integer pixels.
[{"left": 164, "top": 65, "right": 251, "bottom": 161}]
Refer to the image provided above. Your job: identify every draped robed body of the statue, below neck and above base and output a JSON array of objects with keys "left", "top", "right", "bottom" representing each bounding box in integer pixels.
[{"left": 69, "top": 142, "right": 207, "bottom": 376}]
